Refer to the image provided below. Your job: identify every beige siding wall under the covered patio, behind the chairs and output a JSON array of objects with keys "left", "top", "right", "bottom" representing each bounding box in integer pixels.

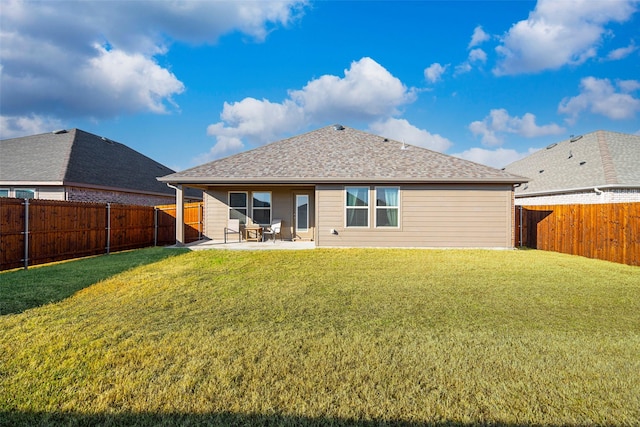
[{"left": 204, "top": 186, "right": 314, "bottom": 240}]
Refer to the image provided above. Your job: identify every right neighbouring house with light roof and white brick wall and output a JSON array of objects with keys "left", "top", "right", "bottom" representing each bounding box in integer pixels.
[{"left": 505, "top": 130, "right": 640, "bottom": 206}]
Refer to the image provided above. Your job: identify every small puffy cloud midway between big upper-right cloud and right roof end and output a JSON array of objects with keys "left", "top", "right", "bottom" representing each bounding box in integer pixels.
[{"left": 469, "top": 108, "right": 565, "bottom": 146}]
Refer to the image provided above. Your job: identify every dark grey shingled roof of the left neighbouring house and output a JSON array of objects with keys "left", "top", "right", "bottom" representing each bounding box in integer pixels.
[{"left": 0, "top": 129, "right": 175, "bottom": 195}]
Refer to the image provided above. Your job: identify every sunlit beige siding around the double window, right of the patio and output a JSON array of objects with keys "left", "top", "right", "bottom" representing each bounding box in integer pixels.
[{"left": 316, "top": 185, "right": 513, "bottom": 248}]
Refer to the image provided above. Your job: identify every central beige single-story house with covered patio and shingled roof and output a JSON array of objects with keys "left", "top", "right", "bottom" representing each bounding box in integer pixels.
[{"left": 159, "top": 125, "right": 527, "bottom": 248}]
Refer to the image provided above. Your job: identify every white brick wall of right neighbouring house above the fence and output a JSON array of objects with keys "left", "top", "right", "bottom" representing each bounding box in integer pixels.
[{"left": 516, "top": 189, "right": 640, "bottom": 206}]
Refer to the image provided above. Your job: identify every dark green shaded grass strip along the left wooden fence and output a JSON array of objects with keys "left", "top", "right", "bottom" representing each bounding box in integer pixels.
[{"left": 0, "top": 247, "right": 188, "bottom": 316}]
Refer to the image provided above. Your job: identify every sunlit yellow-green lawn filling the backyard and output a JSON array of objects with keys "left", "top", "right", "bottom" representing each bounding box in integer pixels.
[{"left": 0, "top": 249, "right": 640, "bottom": 426}]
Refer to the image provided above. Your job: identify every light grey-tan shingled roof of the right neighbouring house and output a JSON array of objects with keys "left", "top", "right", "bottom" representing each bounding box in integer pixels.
[{"left": 505, "top": 130, "right": 640, "bottom": 197}]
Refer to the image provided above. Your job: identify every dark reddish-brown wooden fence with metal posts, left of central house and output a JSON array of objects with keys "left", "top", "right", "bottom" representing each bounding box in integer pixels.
[{"left": 0, "top": 198, "right": 203, "bottom": 270}]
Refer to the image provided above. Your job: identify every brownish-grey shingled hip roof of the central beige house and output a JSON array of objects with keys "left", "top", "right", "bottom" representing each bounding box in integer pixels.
[{"left": 160, "top": 125, "right": 527, "bottom": 184}]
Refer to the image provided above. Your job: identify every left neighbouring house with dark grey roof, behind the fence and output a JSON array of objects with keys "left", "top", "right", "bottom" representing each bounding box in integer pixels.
[{"left": 0, "top": 129, "right": 202, "bottom": 206}]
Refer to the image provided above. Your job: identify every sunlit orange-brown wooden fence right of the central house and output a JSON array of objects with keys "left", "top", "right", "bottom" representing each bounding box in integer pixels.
[{"left": 515, "top": 203, "right": 640, "bottom": 265}]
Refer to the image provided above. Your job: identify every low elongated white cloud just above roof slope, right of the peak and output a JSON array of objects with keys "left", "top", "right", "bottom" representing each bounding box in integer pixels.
[{"left": 369, "top": 118, "right": 453, "bottom": 152}]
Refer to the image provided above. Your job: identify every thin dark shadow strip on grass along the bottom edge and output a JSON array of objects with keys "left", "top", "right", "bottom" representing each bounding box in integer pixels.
[{"left": 0, "top": 411, "right": 559, "bottom": 427}]
